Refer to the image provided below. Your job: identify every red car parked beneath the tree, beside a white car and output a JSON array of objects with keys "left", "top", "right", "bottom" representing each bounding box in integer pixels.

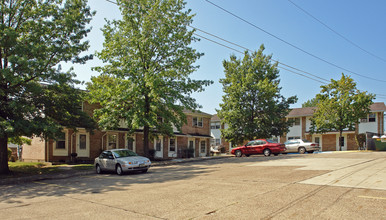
[{"left": 231, "top": 139, "right": 286, "bottom": 157}]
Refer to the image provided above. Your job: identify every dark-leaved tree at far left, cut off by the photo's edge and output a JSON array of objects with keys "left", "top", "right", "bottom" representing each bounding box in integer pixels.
[{"left": 0, "top": 0, "right": 93, "bottom": 174}]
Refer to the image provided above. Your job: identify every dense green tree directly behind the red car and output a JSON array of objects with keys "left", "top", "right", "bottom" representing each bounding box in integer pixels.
[{"left": 218, "top": 45, "right": 297, "bottom": 144}]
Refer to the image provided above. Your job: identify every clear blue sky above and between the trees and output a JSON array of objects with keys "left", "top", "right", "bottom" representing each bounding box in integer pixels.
[{"left": 63, "top": 0, "right": 386, "bottom": 114}]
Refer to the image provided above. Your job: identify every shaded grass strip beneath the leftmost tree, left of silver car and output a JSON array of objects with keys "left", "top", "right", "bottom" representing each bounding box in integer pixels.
[{"left": 8, "top": 162, "right": 93, "bottom": 177}]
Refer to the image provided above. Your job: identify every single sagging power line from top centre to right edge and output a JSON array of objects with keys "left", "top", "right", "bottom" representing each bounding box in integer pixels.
[{"left": 205, "top": 0, "right": 386, "bottom": 82}]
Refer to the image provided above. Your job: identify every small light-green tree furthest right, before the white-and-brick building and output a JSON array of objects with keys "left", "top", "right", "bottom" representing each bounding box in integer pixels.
[{"left": 310, "top": 73, "right": 375, "bottom": 150}]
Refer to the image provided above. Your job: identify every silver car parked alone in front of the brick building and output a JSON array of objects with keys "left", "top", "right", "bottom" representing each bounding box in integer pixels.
[{"left": 94, "top": 149, "right": 151, "bottom": 175}]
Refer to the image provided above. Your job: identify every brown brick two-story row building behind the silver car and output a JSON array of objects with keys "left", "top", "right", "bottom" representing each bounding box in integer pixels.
[{"left": 22, "top": 103, "right": 211, "bottom": 162}]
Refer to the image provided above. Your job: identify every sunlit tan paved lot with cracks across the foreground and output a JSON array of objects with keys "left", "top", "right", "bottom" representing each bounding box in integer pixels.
[{"left": 0, "top": 152, "right": 386, "bottom": 219}]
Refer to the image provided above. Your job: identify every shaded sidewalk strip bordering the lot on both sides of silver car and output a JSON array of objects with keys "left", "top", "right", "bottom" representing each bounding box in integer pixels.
[{"left": 0, "top": 155, "right": 231, "bottom": 185}]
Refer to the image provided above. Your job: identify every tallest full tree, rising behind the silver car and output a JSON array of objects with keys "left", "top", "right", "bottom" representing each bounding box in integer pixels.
[{"left": 88, "top": 0, "right": 212, "bottom": 155}]
